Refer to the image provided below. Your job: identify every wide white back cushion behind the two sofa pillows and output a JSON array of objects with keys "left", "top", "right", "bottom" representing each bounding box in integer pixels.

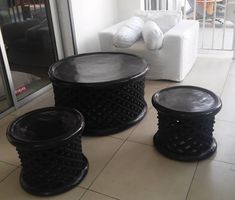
[{"left": 136, "top": 10, "right": 182, "bottom": 33}]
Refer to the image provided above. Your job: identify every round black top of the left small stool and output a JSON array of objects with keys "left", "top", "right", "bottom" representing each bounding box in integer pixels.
[{"left": 7, "top": 107, "right": 85, "bottom": 148}]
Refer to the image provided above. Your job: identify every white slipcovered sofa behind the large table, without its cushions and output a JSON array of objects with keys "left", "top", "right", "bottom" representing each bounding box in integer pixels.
[{"left": 99, "top": 20, "right": 199, "bottom": 81}]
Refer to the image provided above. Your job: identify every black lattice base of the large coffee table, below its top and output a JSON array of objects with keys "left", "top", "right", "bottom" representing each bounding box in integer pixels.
[{"left": 53, "top": 78, "right": 147, "bottom": 136}]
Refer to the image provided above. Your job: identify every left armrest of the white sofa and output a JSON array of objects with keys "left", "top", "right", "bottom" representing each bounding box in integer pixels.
[{"left": 99, "top": 20, "right": 126, "bottom": 51}]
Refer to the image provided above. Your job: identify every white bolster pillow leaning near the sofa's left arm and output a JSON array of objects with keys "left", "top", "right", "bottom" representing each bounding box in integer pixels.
[{"left": 113, "top": 16, "right": 144, "bottom": 48}]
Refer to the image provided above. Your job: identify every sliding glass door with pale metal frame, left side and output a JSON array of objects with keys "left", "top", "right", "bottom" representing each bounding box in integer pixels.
[{"left": 0, "top": 0, "right": 74, "bottom": 115}]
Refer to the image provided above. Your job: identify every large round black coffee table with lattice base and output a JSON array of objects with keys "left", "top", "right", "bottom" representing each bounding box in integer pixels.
[{"left": 49, "top": 52, "right": 148, "bottom": 135}]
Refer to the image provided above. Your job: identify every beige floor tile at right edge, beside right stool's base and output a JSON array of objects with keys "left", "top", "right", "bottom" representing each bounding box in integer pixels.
[{"left": 212, "top": 120, "right": 235, "bottom": 164}]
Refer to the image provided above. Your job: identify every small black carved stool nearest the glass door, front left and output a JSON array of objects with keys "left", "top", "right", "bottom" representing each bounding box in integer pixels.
[{"left": 7, "top": 107, "right": 88, "bottom": 196}]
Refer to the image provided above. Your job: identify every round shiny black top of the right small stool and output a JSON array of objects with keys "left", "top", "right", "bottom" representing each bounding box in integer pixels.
[{"left": 152, "top": 86, "right": 222, "bottom": 114}]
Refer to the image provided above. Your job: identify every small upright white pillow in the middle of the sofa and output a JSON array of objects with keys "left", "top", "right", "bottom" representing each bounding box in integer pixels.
[{"left": 142, "top": 21, "right": 164, "bottom": 50}]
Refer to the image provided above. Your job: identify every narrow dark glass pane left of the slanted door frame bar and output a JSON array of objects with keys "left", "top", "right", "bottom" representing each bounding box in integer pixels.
[{"left": 0, "top": 50, "right": 12, "bottom": 113}]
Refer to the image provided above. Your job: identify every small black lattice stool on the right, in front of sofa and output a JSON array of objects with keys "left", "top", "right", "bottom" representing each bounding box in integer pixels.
[{"left": 152, "top": 86, "right": 222, "bottom": 161}]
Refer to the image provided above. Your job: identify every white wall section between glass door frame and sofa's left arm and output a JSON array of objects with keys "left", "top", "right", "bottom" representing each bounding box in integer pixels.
[{"left": 71, "top": 0, "right": 118, "bottom": 54}]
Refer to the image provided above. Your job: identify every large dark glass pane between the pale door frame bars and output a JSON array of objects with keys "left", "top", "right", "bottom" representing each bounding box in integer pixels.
[{"left": 0, "top": 0, "right": 55, "bottom": 100}]
